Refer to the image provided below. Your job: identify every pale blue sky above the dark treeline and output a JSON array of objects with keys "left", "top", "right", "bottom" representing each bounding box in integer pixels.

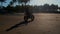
[{"left": 3, "top": 0, "right": 60, "bottom": 6}]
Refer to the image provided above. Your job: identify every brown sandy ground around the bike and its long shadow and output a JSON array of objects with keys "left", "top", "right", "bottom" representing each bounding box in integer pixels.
[{"left": 0, "top": 13, "right": 60, "bottom": 34}]
